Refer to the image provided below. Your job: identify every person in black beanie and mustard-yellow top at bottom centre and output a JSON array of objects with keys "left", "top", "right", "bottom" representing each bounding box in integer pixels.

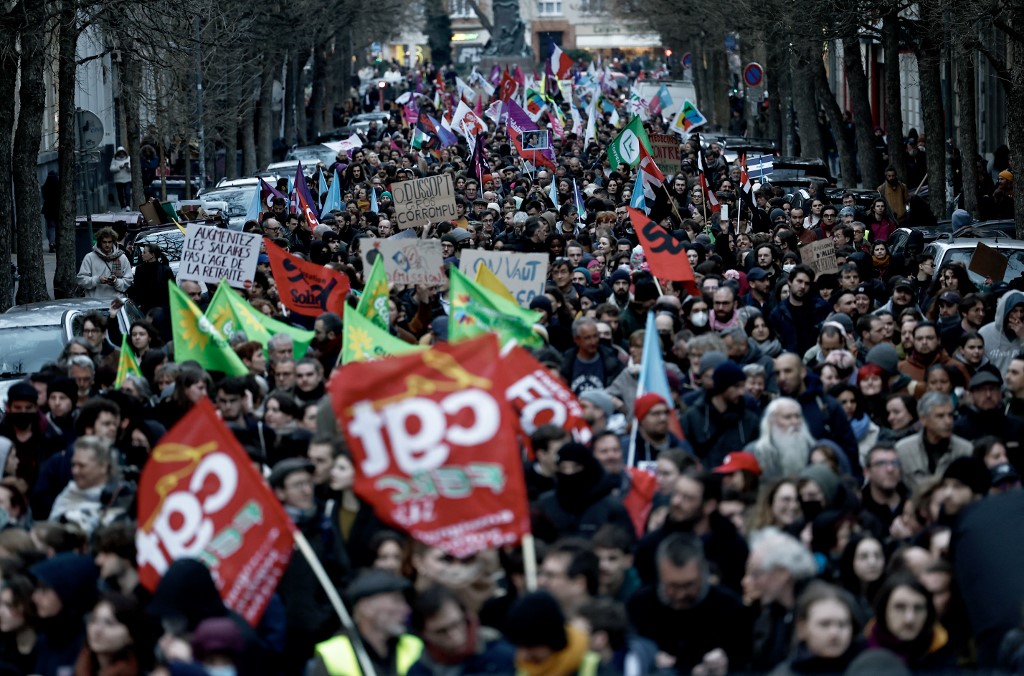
[{"left": 505, "top": 591, "right": 600, "bottom": 676}]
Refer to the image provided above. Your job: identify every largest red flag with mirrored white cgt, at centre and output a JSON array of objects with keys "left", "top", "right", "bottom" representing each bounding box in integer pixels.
[{"left": 328, "top": 335, "right": 529, "bottom": 557}]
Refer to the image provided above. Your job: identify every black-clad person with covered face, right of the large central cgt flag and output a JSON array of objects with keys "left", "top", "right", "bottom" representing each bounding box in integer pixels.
[{"left": 532, "top": 441, "right": 636, "bottom": 542}]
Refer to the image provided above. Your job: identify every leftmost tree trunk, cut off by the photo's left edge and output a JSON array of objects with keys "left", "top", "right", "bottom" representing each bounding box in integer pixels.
[{"left": 0, "top": 36, "right": 15, "bottom": 310}]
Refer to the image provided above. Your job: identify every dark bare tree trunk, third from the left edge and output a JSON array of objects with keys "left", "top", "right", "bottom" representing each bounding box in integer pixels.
[{"left": 52, "top": 0, "right": 78, "bottom": 298}]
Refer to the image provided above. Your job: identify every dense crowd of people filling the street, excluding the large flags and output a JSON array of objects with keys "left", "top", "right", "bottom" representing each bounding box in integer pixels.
[{"left": 8, "top": 60, "right": 1024, "bottom": 676}]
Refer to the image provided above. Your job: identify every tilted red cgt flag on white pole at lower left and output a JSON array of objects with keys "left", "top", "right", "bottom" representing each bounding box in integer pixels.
[{"left": 135, "top": 399, "right": 294, "bottom": 627}]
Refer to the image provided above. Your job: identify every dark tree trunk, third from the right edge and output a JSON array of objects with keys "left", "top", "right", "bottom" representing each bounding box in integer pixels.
[{"left": 916, "top": 2, "right": 952, "bottom": 218}]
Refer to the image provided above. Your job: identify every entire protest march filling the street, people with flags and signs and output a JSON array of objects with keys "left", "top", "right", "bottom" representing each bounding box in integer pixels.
[{"left": 6, "top": 55, "right": 1024, "bottom": 676}]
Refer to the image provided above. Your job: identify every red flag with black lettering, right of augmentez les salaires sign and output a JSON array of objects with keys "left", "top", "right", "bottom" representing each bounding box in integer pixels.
[{"left": 263, "top": 240, "right": 349, "bottom": 316}]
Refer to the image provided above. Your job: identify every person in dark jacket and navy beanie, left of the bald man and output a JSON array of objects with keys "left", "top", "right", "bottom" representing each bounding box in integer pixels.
[{"left": 683, "top": 361, "right": 759, "bottom": 467}]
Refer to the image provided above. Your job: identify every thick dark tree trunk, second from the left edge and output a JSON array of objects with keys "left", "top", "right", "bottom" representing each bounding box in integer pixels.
[{"left": 13, "top": 0, "right": 50, "bottom": 303}]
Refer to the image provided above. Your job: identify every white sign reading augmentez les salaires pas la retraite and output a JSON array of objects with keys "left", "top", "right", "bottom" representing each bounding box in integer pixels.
[{"left": 178, "top": 223, "right": 263, "bottom": 289}]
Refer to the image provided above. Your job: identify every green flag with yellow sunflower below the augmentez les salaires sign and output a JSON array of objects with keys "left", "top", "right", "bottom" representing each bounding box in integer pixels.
[{"left": 167, "top": 282, "right": 249, "bottom": 376}]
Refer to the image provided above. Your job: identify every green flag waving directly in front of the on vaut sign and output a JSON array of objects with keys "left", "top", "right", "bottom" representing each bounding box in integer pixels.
[{"left": 449, "top": 266, "right": 544, "bottom": 347}]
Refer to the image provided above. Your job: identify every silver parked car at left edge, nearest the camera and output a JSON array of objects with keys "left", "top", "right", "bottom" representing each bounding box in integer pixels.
[{"left": 0, "top": 298, "right": 145, "bottom": 411}]
